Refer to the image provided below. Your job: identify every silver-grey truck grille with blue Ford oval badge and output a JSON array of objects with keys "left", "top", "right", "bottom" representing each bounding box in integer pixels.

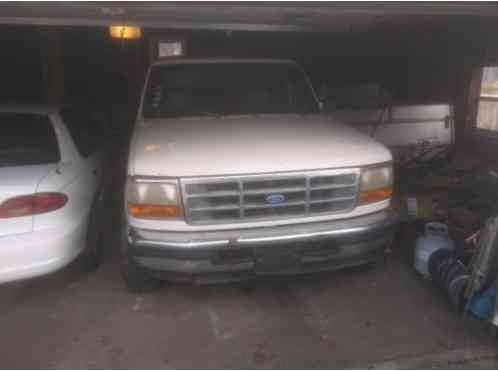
[{"left": 181, "top": 169, "right": 359, "bottom": 224}]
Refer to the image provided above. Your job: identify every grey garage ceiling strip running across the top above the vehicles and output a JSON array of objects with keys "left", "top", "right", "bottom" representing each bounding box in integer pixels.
[{"left": 0, "top": 2, "right": 498, "bottom": 32}]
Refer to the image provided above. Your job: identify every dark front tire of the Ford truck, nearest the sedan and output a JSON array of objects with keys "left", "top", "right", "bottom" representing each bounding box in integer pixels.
[{"left": 121, "top": 233, "right": 161, "bottom": 292}]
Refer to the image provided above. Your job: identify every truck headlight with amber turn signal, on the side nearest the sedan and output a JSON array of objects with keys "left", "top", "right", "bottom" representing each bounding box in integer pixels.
[{"left": 126, "top": 179, "right": 183, "bottom": 219}]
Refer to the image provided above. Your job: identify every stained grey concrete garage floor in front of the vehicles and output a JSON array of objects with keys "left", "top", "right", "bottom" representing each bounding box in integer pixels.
[{"left": 0, "top": 238, "right": 498, "bottom": 369}]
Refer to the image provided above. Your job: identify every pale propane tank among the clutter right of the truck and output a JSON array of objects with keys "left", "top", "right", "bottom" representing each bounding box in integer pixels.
[{"left": 414, "top": 222, "right": 455, "bottom": 277}]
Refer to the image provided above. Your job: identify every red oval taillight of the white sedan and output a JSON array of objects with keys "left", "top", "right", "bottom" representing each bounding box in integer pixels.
[{"left": 0, "top": 192, "right": 67, "bottom": 219}]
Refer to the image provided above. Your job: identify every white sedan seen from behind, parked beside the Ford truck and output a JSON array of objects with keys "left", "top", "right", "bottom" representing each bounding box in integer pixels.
[{"left": 0, "top": 105, "right": 109, "bottom": 283}]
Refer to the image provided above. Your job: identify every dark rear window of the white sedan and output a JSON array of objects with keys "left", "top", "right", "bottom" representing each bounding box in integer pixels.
[{"left": 0, "top": 112, "right": 60, "bottom": 166}]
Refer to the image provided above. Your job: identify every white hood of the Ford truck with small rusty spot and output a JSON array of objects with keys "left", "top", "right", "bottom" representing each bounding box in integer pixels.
[{"left": 129, "top": 114, "right": 391, "bottom": 177}]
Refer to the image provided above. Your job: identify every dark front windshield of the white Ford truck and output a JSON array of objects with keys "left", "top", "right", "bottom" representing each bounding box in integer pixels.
[{"left": 142, "top": 63, "right": 319, "bottom": 118}]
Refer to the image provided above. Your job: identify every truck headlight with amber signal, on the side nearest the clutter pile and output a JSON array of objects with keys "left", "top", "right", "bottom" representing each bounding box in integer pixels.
[{"left": 359, "top": 166, "right": 393, "bottom": 205}]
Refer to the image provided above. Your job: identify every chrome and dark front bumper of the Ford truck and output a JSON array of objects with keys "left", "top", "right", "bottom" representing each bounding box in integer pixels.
[{"left": 126, "top": 210, "right": 398, "bottom": 282}]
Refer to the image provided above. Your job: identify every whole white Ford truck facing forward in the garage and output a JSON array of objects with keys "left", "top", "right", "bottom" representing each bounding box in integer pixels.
[{"left": 122, "top": 59, "right": 396, "bottom": 290}]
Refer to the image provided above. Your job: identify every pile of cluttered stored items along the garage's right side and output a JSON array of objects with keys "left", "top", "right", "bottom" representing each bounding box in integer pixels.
[{"left": 393, "top": 155, "right": 498, "bottom": 333}]
